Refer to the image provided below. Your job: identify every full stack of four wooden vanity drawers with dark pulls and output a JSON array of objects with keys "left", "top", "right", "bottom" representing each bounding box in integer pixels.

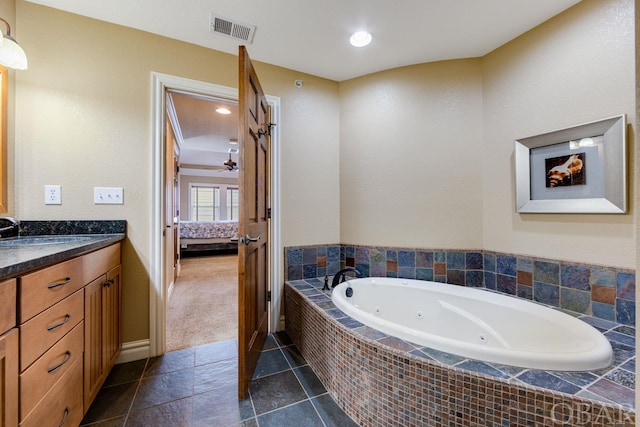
[{"left": 18, "top": 258, "right": 84, "bottom": 427}]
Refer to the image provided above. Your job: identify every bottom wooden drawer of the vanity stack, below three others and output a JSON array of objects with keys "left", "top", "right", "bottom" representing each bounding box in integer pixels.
[{"left": 20, "top": 358, "right": 83, "bottom": 427}]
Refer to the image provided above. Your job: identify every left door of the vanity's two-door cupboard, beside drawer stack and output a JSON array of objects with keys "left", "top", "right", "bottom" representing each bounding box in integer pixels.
[{"left": 84, "top": 275, "right": 107, "bottom": 411}]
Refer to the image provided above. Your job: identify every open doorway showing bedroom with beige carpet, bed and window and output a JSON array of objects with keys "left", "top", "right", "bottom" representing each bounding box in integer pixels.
[{"left": 166, "top": 90, "right": 239, "bottom": 351}]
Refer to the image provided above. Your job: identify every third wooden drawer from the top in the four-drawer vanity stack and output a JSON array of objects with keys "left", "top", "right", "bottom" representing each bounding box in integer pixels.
[{"left": 20, "top": 322, "right": 84, "bottom": 418}]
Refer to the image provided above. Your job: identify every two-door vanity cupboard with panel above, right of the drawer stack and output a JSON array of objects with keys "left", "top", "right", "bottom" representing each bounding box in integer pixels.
[{"left": 84, "top": 245, "right": 122, "bottom": 411}]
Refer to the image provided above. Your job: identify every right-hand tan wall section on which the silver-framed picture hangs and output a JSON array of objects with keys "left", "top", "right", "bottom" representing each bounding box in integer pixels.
[{"left": 482, "top": 0, "right": 636, "bottom": 268}]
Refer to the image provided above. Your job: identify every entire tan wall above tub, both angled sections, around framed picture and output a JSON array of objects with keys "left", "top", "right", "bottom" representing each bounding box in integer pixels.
[{"left": 340, "top": 0, "right": 636, "bottom": 268}]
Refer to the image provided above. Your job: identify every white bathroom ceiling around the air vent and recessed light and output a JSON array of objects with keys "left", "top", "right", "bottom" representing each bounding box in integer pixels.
[{"left": 29, "top": 0, "right": 579, "bottom": 81}]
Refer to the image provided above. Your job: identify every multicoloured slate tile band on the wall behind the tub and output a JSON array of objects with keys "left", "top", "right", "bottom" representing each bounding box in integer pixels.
[{"left": 285, "top": 244, "right": 636, "bottom": 326}]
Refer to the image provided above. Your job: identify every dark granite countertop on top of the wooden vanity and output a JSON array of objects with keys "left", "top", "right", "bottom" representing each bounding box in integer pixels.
[{"left": 0, "top": 233, "right": 125, "bottom": 280}]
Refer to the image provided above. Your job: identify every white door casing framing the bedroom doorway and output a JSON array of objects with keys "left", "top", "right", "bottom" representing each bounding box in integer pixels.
[{"left": 149, "top": 72, "right": 284, "bottom": 357}]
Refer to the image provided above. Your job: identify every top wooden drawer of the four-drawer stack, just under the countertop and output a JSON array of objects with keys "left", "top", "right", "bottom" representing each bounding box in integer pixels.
[{"left": 18, "top": 257, "right": 85, "bottom": 323}]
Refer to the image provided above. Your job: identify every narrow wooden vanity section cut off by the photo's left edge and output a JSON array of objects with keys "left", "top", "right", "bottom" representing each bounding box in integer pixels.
[{"left": 0, "top": 280, "right": 19, "bottom": 427}]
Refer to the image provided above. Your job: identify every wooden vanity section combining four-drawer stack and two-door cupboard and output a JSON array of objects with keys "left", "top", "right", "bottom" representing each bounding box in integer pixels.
[{"left": 14, "top": 243, "right": 122, "bottom": 427}]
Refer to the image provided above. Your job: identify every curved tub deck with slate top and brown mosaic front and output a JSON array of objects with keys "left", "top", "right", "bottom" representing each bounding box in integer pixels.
[{"left": 285, "top": 279, "right": 635, "bottom": 426}]
